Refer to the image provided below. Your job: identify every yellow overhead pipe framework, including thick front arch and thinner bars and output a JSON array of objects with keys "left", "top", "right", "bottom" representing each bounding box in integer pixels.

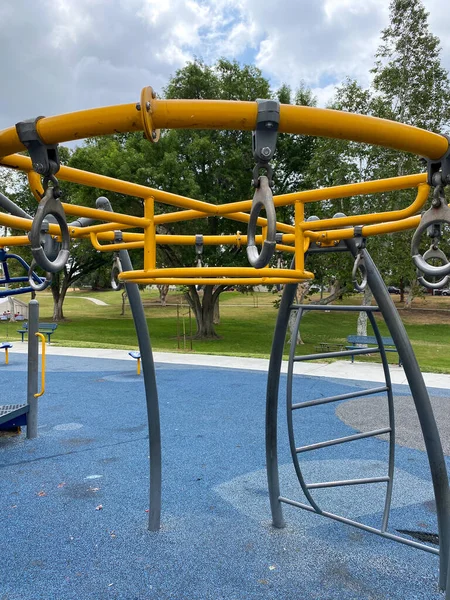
[{"left": 0, "top": 88, "right": 449, "bottom": 283}]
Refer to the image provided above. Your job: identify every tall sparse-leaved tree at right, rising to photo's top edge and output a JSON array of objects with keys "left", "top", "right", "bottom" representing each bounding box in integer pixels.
[{"left": 372, "top": 0, "right": 450, "bottom": 302}]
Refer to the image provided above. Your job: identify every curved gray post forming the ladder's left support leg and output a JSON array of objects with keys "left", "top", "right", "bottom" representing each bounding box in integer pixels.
[{"left": 266, "top": 283, "right": 297, "bottom": 528}]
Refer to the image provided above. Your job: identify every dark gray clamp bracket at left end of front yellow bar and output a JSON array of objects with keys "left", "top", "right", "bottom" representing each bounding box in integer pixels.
[{"left": 16, "top": 117, "right": 60, "bottom": 178}]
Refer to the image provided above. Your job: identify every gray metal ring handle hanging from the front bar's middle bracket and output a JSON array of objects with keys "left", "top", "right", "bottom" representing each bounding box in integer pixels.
[{"left": 247, "top": 175, "right": 277, "bottom": 269}]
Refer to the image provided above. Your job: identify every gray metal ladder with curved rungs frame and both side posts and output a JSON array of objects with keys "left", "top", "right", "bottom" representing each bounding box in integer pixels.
[{"left": 266, "top": 240, "right": 450, "bottom": 600}]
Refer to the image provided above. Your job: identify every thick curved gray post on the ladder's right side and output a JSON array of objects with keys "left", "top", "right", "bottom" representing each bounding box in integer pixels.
[{"left": 347, "top": 240, "right": 450, "bottom": 591}]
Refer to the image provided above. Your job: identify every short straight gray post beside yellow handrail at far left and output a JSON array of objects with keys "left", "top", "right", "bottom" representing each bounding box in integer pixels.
[{"left": 27, "top": 300, "right": 39, "bottom": 439}]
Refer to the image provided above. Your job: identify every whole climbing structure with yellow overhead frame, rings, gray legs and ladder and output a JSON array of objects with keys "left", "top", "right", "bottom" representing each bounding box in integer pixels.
[{"left": 0, "top": 87, "right": 450, "bottom": 598}]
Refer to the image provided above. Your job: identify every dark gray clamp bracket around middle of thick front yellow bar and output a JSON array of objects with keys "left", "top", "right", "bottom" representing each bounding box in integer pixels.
[{"left": 252, "top": 99, "right": 280, "bottom": 187}]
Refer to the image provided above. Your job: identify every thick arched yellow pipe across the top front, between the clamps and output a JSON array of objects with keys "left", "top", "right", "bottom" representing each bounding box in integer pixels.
[{"left": 0, "top": 99, "right": 449, "bottom": 159}]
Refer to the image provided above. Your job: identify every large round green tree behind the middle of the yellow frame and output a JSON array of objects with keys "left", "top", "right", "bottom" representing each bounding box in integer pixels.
[{"left": 70, "top": 60, "right": 312, "bottom": 338}]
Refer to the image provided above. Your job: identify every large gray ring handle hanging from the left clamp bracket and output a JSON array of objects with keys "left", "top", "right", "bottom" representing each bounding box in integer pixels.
[{"left": 29, "top": 187, "right": 70, "bottom": 273}]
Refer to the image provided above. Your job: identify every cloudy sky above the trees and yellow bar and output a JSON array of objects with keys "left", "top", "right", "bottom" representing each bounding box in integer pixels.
[{"left": 0, "top": 0, "right": 450, "bottom": 129}]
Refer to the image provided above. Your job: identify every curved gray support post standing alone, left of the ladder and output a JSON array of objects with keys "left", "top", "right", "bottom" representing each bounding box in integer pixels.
[{"left": 119, "top": 250, "right": 162, "bottom": 531}]
